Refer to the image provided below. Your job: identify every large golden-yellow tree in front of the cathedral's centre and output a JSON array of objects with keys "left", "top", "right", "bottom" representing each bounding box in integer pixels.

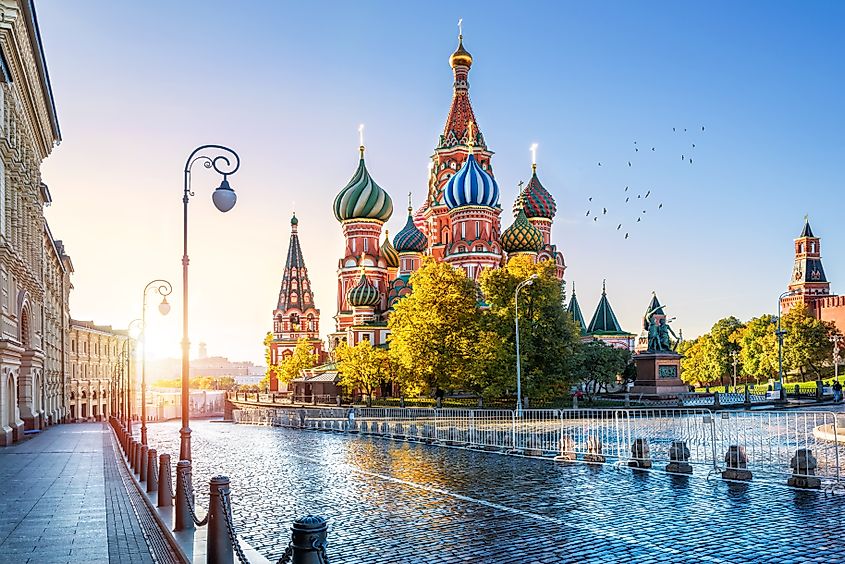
[{"left": 388, "top": 258, "right": 495, "bottom": 389}]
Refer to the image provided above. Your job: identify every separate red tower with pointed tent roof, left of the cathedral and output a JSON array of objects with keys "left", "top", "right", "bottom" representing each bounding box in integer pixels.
[{"left": 270, "top": 214, "right": 323, "bottom": 391}]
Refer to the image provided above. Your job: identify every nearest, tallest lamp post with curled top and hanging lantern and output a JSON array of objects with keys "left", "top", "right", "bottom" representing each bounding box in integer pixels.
[{"left": 179, "top": 145, "right": 241, "bottom": 460}]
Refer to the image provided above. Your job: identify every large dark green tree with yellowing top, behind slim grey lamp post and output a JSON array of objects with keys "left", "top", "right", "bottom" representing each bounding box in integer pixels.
[{"left": 480, "top": 256, "right": 580, "bottom": 397}]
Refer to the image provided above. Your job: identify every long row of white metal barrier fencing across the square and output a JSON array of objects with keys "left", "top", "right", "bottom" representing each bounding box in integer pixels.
[{"left": 234, "top": 407, "right": 845, "bottom": 485}]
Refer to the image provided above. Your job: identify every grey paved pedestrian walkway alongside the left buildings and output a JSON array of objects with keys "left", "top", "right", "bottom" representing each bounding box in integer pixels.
[{"left": 0, "top": 423, "right": 177, "bottom": 564}]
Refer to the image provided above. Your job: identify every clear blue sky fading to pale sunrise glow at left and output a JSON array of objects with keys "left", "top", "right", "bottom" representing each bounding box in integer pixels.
[{"left": 38, "top": 0, "right": 845, "bottom": 360}]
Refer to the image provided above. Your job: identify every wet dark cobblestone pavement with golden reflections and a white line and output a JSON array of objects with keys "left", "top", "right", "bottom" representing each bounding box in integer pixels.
[{"left": 149, "top": 422, "right": 845, "bottom": 564}]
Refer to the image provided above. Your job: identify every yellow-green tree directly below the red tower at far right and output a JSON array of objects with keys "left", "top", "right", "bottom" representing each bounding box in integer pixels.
[{"left": 781, "top": 305, "right": 839, "bottom": 382}]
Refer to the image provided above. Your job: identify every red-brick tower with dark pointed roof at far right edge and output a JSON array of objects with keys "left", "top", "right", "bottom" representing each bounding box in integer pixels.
[{"left": 781, "top": 219, "right": 845, "bottom": 333}]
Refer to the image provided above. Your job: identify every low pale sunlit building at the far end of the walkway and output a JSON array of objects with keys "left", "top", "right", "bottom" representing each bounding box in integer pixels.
[{"left": 68, "top": 320, "right": 128, "bottom": 421}]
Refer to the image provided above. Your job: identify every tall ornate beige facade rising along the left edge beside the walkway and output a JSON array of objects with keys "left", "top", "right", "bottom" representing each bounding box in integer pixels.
[{"left": 0, "top": 0, "right": 72, "bottom": 444}]
